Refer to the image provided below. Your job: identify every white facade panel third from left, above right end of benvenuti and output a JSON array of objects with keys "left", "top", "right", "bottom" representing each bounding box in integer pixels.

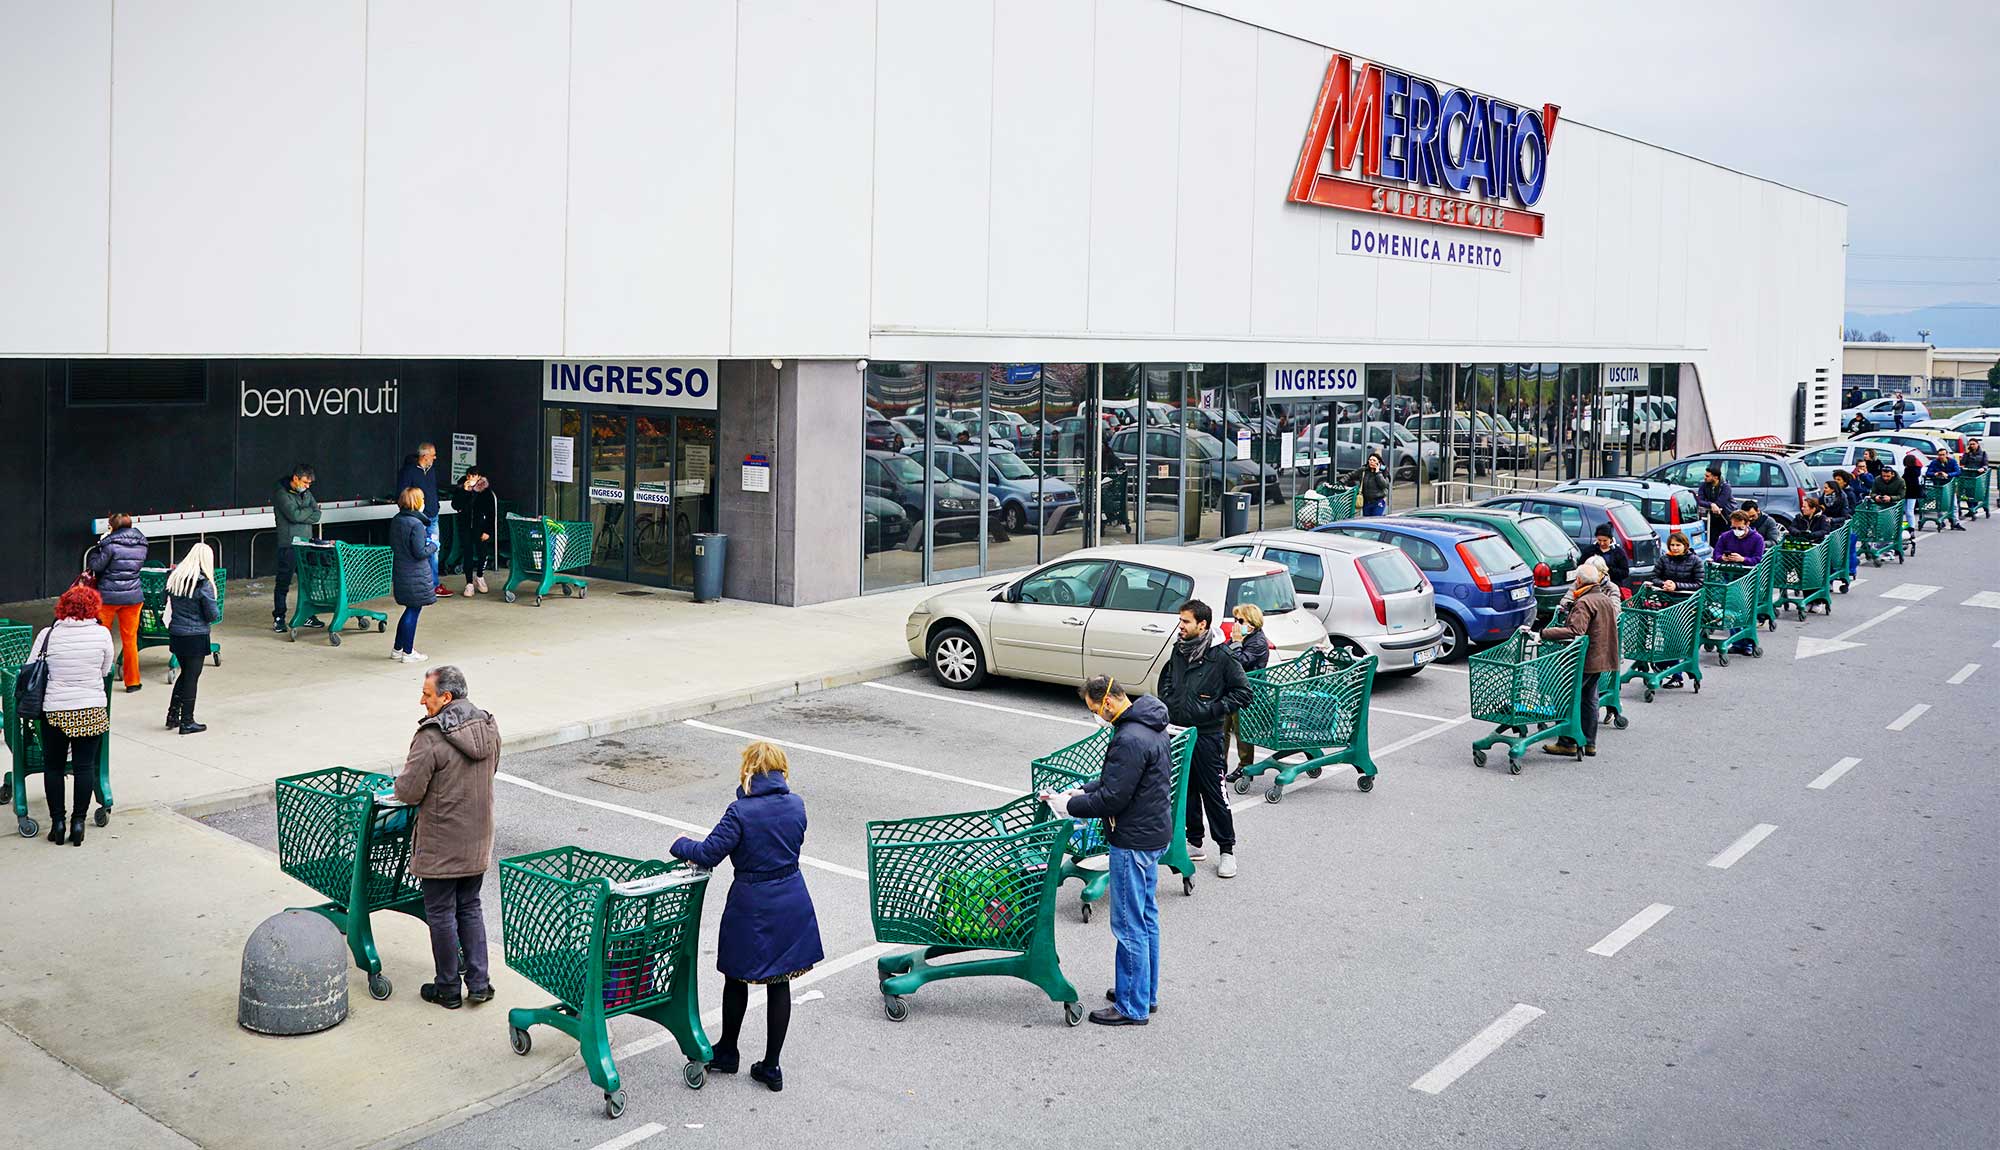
[{"left": 362, "top": 0, "right": 570, "bottom": 356}]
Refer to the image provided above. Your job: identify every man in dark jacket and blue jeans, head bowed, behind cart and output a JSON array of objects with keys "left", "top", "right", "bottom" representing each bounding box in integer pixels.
[{"left": 1042, "top": 674, "right": 1174, "bottom": 1026}]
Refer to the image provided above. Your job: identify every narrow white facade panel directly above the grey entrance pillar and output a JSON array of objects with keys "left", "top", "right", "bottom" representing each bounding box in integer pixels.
[{"left": 730, "top": 0, "right": 868, "bottom": 356}]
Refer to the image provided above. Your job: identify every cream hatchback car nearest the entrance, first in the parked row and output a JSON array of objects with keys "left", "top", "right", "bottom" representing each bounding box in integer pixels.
[{"left": 904, "top": 546, "right": 1326, "bottom": 692}]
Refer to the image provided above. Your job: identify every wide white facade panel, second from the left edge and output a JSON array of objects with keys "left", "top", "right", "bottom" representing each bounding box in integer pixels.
[{"left": 110, "top": 0, "right": 366, "bottom": 356}]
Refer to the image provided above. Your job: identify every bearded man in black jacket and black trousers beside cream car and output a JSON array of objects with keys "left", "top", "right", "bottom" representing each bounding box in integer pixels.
[{"left": 1160, "top": 598, "right": 1250, "bottom": 878}]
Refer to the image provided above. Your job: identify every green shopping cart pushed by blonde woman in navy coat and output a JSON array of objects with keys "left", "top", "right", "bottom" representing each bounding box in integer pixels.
[{"left": 500, "top": 846, "right": 714, "bottom": 1118}]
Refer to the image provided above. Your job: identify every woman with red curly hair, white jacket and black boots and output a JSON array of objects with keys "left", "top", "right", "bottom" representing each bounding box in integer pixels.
[{"left": 28, "top": 584, "right": 116, "bottom": 846}]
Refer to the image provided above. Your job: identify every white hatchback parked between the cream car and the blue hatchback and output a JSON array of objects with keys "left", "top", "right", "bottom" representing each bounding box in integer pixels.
[{"left": 1208, "top": 528, "right": 1444, "bottom": 674}]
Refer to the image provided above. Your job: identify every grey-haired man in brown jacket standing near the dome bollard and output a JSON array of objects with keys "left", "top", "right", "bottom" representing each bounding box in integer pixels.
[{"left": 396, "top": 666, "right": 500, "bottom": 1010}]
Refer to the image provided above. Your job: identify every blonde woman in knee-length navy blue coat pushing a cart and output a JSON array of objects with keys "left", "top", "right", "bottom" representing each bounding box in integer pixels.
[{"left": 672, "top": 742, "right": 826, "bottom": 1090}]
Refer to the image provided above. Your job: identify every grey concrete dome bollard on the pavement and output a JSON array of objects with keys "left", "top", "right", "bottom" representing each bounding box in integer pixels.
[{"left": 236, "top": 910, "right": 348, "bottom": 1034}]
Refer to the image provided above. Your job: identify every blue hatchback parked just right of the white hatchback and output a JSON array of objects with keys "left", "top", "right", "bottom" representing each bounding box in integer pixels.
[{"left": 1320, "top": 516, "right": 1534, "bottom": 662}]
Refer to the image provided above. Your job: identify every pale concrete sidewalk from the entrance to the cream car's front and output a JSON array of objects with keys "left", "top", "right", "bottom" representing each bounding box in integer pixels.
[{"left": 0, "top": 578, "right": 968, "bottom": 820}]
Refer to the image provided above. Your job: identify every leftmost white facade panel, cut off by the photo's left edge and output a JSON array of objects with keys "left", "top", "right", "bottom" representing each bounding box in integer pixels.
[{"left": 0, "top": 0, "right": 112, "bottom": 354}]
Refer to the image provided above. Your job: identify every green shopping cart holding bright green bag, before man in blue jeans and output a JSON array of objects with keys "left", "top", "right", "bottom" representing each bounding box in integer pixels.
[{"left": 868, "top": 794, "right": 1084, "bottom": 1026}]
